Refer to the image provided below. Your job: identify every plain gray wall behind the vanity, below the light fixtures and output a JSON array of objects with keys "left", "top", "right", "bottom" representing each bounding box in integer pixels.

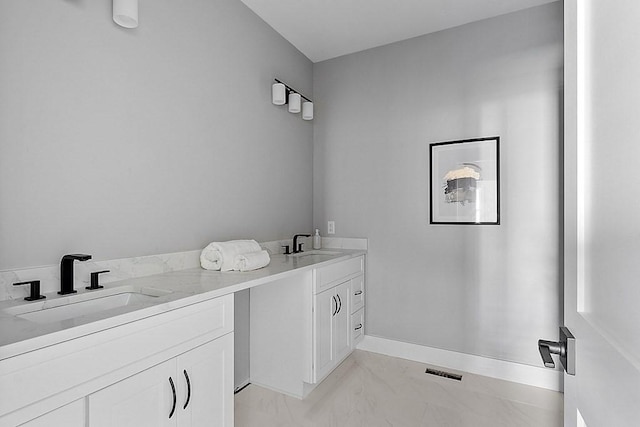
[{"left": 0, "top": 0, "right": 313, "bottom": 269}]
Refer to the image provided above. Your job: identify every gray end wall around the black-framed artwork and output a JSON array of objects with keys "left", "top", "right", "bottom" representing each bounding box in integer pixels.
[{"left": 313, "top": 2, "right": 563, "bottom": 366}]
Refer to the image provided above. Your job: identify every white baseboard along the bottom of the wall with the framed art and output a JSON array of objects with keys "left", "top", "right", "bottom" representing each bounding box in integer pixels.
[{"left": 357, "top": 335, "right": 563, "bottom": 391}]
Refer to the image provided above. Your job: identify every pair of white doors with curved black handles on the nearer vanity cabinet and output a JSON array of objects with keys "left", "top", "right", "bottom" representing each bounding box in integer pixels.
[{"left": 88, "top": 334, "right": 233, "bottom": 427}]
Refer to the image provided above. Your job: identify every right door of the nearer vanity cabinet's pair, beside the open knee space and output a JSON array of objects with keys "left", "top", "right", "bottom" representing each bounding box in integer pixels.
[{"left": 177, "top": 333, "right": 233, "bottom": 427}]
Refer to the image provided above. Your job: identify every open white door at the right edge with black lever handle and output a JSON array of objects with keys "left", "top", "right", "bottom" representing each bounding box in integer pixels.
[{"left": 564, "top": 0, "right": 640, "bottom": 427}]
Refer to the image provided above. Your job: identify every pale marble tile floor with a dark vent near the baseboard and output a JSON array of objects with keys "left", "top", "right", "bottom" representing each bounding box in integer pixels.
[{"left": 235, "top": 350, "right": 563, "bottom": 427}]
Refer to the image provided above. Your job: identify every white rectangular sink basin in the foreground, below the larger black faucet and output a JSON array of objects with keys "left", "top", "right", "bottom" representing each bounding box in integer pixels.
[{"left": 3, "top": 286, "right": 171, "bottom": 323}]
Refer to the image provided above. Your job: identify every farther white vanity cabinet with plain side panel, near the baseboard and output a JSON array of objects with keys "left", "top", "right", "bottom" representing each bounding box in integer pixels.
[{"left": 249, "top": 255, "right": 365, "bottom": 399}]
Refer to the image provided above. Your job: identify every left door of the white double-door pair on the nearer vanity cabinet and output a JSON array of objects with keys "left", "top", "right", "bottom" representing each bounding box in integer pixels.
[{"left": 89, "top": 359, "right": 178, "bottom": 427}]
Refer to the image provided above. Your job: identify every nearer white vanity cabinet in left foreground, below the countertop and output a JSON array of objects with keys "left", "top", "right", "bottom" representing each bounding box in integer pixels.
[{"left": 0, "top": 294, "right": 233, "bottom": 427}]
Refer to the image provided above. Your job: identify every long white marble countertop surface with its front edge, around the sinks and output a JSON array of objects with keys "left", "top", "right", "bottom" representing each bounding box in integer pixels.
[{"left": 0, "top": 249, "right": 366, "bottom": 360}]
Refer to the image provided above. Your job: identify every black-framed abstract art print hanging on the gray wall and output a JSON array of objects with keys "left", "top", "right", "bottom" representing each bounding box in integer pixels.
[{"left": 429, "top": 136, "right": 500, "bottom": 225}]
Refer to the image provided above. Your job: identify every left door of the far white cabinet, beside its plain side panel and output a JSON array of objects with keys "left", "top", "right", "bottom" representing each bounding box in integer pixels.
[{"left": 313, "top": 288, "right": 338, "bottom": 382}]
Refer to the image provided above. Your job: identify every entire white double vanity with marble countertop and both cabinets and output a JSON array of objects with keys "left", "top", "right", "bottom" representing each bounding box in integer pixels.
[{"left": 0, "top": 250, "right": 365, "bottom": 427}]
